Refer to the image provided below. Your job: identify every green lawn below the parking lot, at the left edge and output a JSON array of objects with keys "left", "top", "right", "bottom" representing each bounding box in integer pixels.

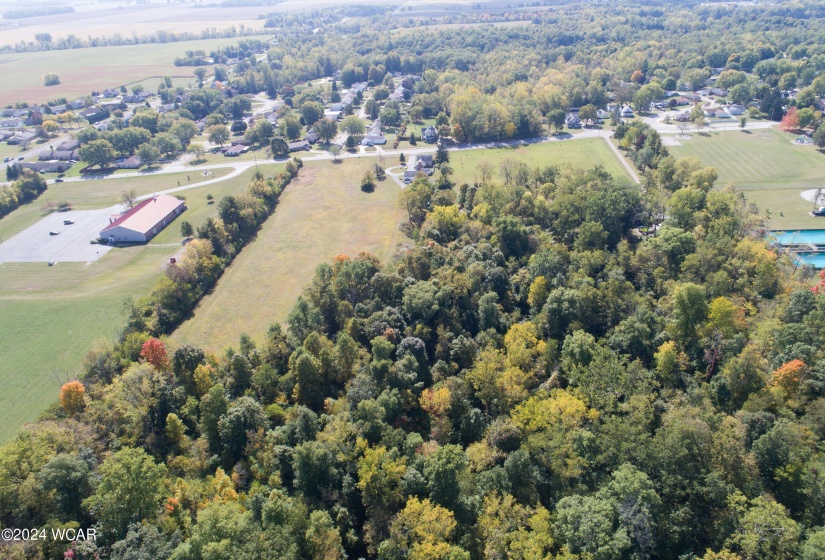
[{"left": 0, "top": 247, "right": 176, "bottom": 443}]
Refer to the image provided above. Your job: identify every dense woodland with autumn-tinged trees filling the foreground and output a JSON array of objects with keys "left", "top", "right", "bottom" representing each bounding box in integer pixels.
[{"left": 0, "top": 160, "right": 825, "bottom": 560}]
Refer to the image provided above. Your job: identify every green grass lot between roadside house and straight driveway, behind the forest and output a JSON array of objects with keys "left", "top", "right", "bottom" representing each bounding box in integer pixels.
[{"left": 450, "top": 138, "right": 630, "bottom": 184}]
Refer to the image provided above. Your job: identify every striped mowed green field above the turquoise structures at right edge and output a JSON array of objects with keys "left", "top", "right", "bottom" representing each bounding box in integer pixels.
[{"left": 669, "top": 129, "right": 825, "bottom": 229}]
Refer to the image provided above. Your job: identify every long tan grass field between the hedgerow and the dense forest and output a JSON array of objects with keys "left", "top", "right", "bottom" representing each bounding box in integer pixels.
[{"left": 171, "top": 158, "right": 408, "bottom": 351}]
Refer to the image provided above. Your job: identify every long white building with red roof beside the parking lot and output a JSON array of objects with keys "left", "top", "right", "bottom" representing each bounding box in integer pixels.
[{"left": 100, "top": 194, "right": 186, "bottom": 243}]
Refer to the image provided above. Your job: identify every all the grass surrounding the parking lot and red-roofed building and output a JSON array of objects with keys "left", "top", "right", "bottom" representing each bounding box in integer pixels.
[{"left": 0, "top": 166, "right": 251, "bottom": 443}]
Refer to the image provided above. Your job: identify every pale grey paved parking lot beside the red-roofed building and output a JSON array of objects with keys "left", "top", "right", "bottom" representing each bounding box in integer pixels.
[{"left": 0, "top": 207, "right": 118, "bottom": 263}]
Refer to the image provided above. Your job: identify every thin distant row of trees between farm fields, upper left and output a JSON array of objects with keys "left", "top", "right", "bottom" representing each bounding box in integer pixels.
[{"left": 0, "top": 25, "right": 261, "bottom": 53}]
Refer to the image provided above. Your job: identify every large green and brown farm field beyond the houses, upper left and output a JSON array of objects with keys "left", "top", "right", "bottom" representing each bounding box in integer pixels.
[{"left": 0, "top": 35, "right": 266, "bottom": 106}]
